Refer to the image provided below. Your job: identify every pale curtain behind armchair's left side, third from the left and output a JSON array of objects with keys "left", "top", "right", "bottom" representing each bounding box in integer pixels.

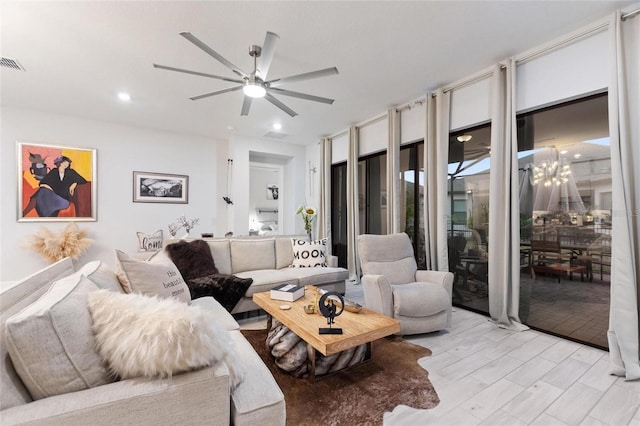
[{"left": 387, "top": 108, "right": 402, "bottom": 234}]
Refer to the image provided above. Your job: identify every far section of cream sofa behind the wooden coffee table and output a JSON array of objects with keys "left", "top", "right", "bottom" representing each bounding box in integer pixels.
[{"left": 165, "top": 235, "right": 349, "bottom": 314}]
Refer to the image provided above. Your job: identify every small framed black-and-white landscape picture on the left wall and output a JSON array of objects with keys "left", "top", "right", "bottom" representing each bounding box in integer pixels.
[{"left": 133, "top": 172, "right": 189, "bottom": 204}]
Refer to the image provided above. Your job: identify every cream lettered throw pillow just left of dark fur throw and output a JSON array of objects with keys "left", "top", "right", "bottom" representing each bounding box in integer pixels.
[{"left": 116, "top": 250, "right": 191, "bottom": 304}]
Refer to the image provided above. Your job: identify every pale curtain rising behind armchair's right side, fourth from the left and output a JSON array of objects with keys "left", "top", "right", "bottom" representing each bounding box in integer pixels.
[{"left": 423, "top": 89, "right": 451, "bottom": 271}]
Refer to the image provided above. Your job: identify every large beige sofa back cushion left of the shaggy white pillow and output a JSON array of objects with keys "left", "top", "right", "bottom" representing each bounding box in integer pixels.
[{"left": 4, "top": 273, "right": 112, "bottom": 400}]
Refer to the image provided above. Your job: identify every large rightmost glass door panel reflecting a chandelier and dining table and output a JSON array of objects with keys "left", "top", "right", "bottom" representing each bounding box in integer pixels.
[{"left": 518, "top": 94, "right": 612, "bottom": 349}]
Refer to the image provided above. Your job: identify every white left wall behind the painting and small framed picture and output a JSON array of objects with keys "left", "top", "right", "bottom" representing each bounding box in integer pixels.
[{"left": 0, "top": 108, "right": 226, "bottom": 281}]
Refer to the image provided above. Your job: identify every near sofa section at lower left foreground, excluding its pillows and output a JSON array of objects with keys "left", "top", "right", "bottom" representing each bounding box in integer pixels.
[{"left": 0, "top": 256, "right": 286, "bottom": 426}]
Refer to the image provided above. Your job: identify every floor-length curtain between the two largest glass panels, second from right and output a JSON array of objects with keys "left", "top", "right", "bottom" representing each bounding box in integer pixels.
[{"left": 488, "top": 59, "right": 527, "bottom": 330}]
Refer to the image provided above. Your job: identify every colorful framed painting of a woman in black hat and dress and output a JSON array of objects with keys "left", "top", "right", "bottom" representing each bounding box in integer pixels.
[{"left": 17, "top": 142, "right": 97, "bottom": 222}]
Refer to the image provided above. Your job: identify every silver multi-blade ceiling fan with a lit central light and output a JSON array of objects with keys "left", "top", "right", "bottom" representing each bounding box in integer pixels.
[{"left": 153, "top": 31, "right": 338, "bottom": 117}]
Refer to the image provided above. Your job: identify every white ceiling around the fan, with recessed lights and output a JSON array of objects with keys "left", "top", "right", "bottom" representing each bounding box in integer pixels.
[{"left": 0, "top": 1, "right": 633, "bottom": 144}]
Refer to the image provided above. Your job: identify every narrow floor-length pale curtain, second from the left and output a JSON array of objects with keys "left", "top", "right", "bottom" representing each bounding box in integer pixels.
[{"left": 347, "top": 126, "right": 360, "bottom": 283}]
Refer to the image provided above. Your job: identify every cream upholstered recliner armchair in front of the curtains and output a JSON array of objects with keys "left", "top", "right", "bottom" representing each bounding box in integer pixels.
[{"left": 358, "top": 233, "right": 453, "bottom": 335}]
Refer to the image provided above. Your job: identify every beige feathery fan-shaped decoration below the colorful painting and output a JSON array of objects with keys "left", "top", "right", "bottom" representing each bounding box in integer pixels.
[{"left": 26, "top": 222, "right": 93, "bottom": 263}]
